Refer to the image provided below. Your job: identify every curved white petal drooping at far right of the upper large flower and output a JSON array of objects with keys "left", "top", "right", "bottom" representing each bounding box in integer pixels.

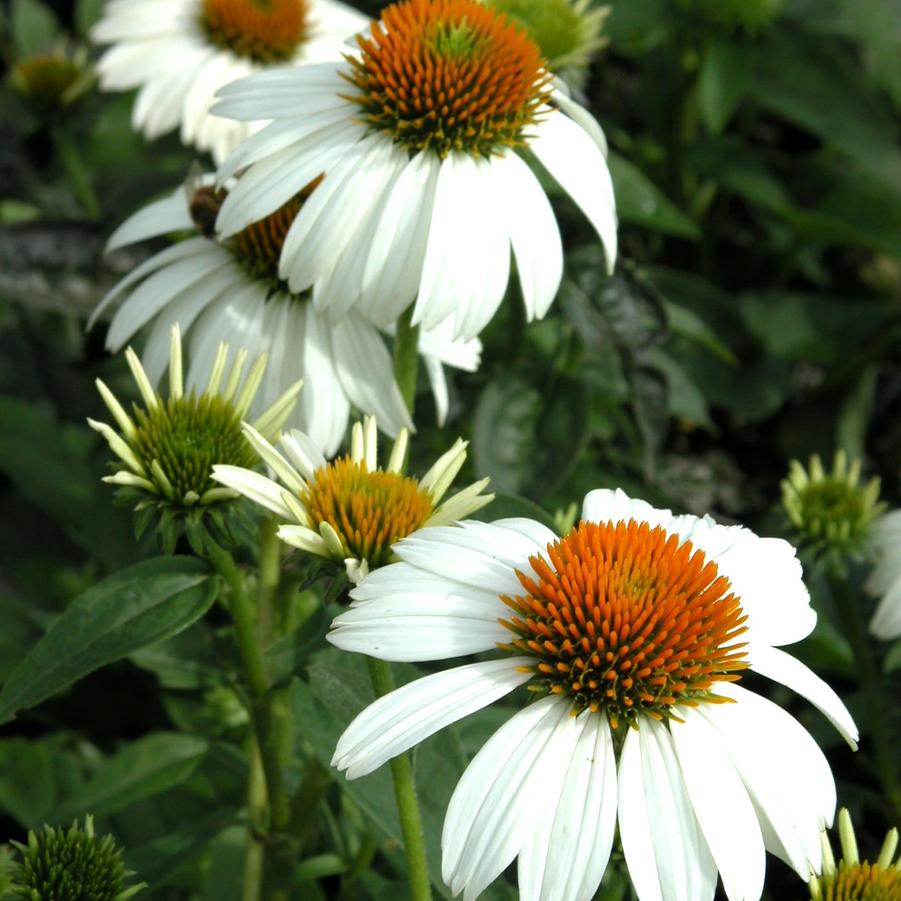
[{"left": 529, "top": 110, "right": 617, "bottom": 272}]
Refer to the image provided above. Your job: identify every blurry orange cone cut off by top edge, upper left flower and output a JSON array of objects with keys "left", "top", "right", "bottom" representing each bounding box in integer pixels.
[{"left": 200, "top": 0, "right": 307, "bottom": 63}]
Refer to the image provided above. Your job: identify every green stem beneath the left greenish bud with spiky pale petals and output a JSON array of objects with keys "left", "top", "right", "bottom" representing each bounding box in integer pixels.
[{"left": 206, "top": 540, "right": 289, "bottom": 832}]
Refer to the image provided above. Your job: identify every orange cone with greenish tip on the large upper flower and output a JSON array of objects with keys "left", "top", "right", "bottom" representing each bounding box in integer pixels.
[{"left": 347, "top": 0, "right": 551, "bottom": 159}]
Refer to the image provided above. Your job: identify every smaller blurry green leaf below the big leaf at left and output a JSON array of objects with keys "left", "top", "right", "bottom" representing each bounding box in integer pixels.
[{"left": 51, "top": 732, "right": 209, "bottom": 823}]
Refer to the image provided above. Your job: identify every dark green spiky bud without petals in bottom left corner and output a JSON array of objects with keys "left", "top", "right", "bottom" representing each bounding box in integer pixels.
[{"left": 12, "top": 817, "right": 145, "bottom": 901}]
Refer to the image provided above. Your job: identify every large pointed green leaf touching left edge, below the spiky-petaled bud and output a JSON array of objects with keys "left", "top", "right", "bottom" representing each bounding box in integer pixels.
[{"left": 0, "top": 557, "right": 218, "bottom": 723}]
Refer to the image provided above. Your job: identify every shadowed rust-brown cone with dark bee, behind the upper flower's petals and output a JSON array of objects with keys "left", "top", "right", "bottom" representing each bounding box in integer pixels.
[{"left": 188, "top": 175, "right": 322, "bottom": 294}]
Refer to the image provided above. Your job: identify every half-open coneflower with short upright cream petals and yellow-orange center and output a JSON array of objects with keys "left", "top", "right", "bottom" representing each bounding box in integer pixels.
[{"left": 213, "top": 416, "right": 494, "bottom": 582}]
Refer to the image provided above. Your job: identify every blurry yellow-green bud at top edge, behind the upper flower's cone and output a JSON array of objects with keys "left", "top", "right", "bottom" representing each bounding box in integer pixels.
[{"left": 484, "top": 0, "right": 610, "bottom": 80}]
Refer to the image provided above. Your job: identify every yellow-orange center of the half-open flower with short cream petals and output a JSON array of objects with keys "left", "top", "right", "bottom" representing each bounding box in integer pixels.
[{"left": 300, "top": 457, "right": 432, "bottom": 568}]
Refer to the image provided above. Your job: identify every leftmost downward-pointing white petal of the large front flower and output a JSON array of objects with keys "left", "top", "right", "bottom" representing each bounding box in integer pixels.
[{"left": 441, "top": 697, "right": 577, "bottom": 901}]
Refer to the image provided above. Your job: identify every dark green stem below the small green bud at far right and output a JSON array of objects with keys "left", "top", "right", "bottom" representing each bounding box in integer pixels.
[{"left": 829, "top": 570, "right": 901, "bottom": 821}]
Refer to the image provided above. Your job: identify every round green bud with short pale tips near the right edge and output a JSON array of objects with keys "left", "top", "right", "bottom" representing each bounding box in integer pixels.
[{"left": 782, "top": 451, "right": 886, "bottom": 561}]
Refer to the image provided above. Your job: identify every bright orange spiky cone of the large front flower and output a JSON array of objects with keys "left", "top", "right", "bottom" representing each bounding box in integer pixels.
[{"left": 501, "top": 520, "right": 748, "bottom": 728}]
